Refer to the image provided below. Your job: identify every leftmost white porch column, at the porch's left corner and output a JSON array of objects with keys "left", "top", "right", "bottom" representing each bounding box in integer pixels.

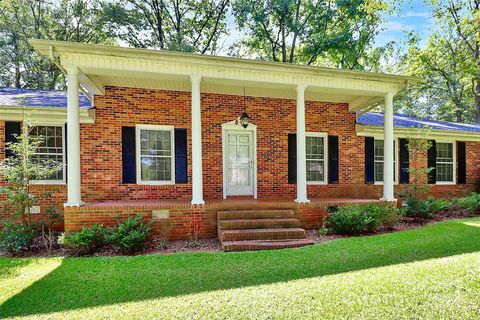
[{"left": 65, "top": 66, "right": 84, "bottom": 207}]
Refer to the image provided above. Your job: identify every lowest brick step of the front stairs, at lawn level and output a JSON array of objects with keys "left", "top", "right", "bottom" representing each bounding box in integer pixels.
[{"left": 222, "top": 239, "right": 314, "bottom": 251}]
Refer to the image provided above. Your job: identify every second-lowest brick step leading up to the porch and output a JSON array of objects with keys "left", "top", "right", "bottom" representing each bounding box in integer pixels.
[{"left": 220, "top": 228, "right": 306, "bottom": 241}]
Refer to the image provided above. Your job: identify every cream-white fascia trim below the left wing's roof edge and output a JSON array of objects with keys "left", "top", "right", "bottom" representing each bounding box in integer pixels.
[{"left": 0, "top": 106, "right": 95, "bottom": 125}]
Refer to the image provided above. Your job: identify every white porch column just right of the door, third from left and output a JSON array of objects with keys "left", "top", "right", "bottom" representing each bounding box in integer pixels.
[{"left": 295, "top": 85, "right": 310, "bottom": 203}]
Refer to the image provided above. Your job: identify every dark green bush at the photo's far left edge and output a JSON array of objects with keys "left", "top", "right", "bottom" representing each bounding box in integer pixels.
[{"left": 0, "top": 221, "right": 36, "bottom": 254}]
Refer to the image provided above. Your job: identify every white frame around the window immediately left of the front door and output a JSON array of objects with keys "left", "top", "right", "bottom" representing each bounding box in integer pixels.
[{"left": 135, "top": 124, "right": 175, "bottom": 186}]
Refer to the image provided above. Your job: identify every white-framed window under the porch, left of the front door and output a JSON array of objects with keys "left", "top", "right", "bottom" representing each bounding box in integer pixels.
[{"left": 136, "top": 125, "right": 175, "bottom": 184}]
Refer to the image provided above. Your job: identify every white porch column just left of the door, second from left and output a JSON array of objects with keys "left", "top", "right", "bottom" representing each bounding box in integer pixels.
[{"left": 190, "top": 76, "right": 205, "bottom": 205}]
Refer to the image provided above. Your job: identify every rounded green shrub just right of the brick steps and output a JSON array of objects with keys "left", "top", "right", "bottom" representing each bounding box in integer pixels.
[{"left": 328, "top": 205, "right": 379, "bottom": 234}]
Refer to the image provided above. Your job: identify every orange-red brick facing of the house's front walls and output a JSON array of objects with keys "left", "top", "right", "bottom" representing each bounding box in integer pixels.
[{"left": 0, "top": 87, "right": 480, "bottom": 237}]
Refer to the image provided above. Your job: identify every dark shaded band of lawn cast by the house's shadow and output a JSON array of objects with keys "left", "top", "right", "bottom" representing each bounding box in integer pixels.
[{"left": 0, "top": 218, "right": 480, "bottom": 318}]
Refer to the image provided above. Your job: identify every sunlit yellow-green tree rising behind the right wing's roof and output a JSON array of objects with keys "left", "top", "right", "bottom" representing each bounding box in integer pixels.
[{"left": 403, "top": 26, "right": 476, "bottom": 122}]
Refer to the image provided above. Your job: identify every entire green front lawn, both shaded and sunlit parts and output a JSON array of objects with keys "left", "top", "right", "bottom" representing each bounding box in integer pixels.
[{"left": 0, "top": 218, "right": 480, "bottom": 319}]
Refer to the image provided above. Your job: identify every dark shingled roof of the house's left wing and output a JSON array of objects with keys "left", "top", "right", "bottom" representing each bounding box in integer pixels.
[{"left": 0, "top": 88, "right": 92, "bottom": 108}]
